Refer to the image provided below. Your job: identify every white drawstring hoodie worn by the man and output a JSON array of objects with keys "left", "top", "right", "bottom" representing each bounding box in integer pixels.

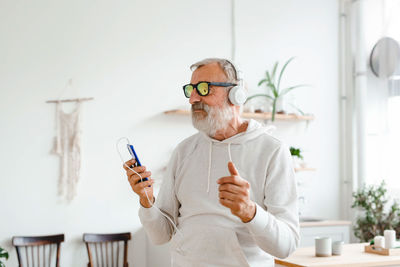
[{"left": 139, "top": 120, "right": 299, "bottom": 267}]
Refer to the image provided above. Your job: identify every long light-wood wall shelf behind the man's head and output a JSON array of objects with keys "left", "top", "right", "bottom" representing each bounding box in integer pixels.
[{"left": 164, "top": 109, "right": 314, "bottom": 121}]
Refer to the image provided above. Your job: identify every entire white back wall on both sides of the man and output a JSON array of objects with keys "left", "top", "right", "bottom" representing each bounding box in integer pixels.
[{"left": 0, "top": 0, "right": 340, "bottom": 266}]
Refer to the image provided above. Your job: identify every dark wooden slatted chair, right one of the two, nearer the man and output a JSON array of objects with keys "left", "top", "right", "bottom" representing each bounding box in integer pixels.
[{"left": 83, "top": 233, "right": 131, "bottom": 267}]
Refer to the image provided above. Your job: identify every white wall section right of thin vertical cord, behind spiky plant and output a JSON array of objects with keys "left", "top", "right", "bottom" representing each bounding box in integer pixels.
[{"left": 237, "top": 0, "right": 340, "bottom": 221}]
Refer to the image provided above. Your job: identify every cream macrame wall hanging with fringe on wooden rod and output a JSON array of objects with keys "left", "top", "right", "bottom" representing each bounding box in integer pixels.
[{"left": 46, "top": 98, "right": 93, "bottom": 202}]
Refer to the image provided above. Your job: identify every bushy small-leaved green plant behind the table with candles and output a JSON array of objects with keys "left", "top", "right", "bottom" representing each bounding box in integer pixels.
[{"left": 351, "top": 181, "right": 400, "bottom": 242}]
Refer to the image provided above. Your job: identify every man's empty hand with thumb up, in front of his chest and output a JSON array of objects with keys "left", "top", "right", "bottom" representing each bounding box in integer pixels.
[{"left": 217, "top": 162, "right": 256, "bottom": 223}]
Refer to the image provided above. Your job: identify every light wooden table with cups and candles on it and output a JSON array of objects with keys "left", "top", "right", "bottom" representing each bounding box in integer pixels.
[{"left": 275, "top": 243, "right": 400, "bottom": 267}]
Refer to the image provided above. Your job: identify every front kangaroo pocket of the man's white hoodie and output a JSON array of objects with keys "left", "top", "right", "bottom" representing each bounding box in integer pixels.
[{"left": 171, "top": 224, "right": 249, "bottom": 267}]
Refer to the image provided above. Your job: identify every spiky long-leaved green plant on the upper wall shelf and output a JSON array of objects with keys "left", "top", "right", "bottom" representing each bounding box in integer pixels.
[{"left": 246, "top": 57, "right": 307, "bottom": 121}]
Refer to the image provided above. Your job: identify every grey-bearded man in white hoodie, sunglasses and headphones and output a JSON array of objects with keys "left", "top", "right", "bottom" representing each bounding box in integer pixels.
[{"left": 124, "top": 58, "right": 299, "bottom": 267}]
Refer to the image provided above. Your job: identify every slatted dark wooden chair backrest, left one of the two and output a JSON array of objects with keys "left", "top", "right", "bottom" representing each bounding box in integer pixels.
[{"left": 12, "top": 234, "right": 64, "bottom": 267}]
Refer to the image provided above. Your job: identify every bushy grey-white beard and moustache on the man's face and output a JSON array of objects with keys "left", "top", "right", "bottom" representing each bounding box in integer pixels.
[{"left": 192, "top": 101, "right": 234, "bottom": 137}]
